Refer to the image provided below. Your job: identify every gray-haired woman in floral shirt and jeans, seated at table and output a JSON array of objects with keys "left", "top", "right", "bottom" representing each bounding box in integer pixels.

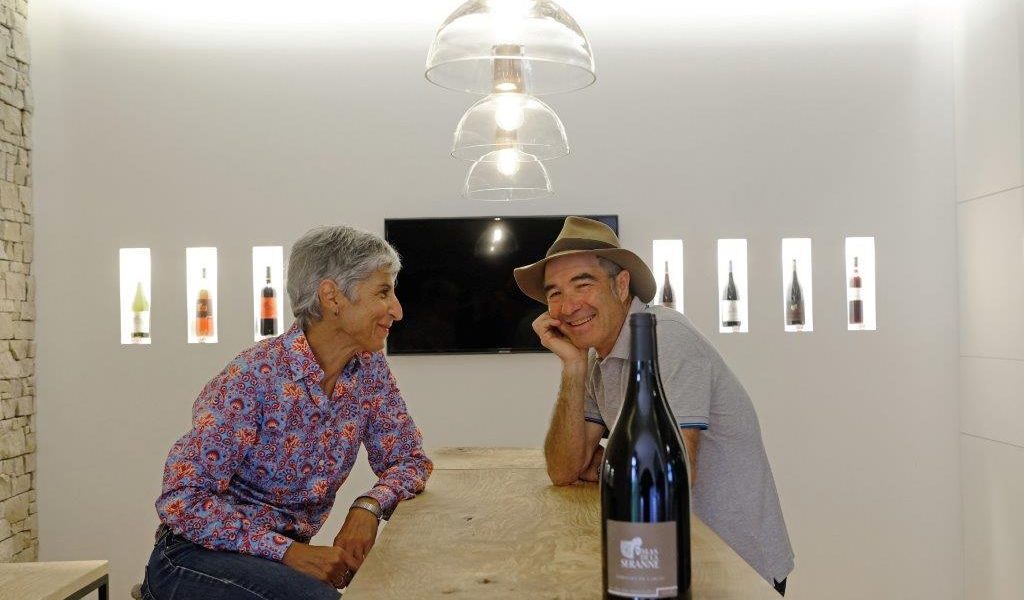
[{"left": 142, "top": 226, "right": 432, "bottom": 600}]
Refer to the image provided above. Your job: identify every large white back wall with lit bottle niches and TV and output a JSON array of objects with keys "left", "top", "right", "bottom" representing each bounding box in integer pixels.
[{"left": 30, "top": 0, "right": 962, "bottom": 600}]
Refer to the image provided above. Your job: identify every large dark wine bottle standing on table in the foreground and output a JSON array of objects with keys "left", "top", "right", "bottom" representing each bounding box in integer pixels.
[{"left": 601, "top": 312, "right": 691, "bottom": 600}]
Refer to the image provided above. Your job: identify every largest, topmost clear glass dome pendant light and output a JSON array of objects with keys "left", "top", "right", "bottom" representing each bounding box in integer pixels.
[{"left": 425, "top": 0, "right": 596, "bottom": 96}]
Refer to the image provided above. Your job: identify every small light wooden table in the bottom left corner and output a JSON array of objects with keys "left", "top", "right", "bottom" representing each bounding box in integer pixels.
[{"left": 0, "top": 560, "right": 108, "bottom": 600}]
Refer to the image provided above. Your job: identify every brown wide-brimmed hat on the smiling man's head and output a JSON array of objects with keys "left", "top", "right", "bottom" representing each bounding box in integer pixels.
[{"left": 513, "top": 217, "right": 657, "bottom": 304}]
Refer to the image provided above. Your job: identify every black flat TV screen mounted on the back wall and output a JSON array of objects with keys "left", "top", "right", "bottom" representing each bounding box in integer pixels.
[{"left": 384, "top": 215, "right": 618, "bottom": 354}]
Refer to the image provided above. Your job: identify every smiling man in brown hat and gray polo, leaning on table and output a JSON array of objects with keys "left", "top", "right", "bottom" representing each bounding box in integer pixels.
[{"left": 515, "top": 217, "right": 794, "bottom": 595}]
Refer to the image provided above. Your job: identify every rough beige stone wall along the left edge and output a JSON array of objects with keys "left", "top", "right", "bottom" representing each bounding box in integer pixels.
[{"left": 0, "top": 0, "right": 33, "bottom": 562}]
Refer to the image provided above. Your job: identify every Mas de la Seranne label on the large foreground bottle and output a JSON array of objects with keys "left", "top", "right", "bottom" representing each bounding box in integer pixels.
[{"left": 605, "top": 519, "right": 679, "bottom": 598}]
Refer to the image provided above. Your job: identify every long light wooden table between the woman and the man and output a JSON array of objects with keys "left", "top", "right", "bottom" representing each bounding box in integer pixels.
[{"left": 344, "top": 448, "right": 779, "bottom": 600}]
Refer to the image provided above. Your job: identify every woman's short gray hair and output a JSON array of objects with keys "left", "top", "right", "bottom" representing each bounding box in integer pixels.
[{"left": 288, "top": 225, "right": 401, "bottom": 327}]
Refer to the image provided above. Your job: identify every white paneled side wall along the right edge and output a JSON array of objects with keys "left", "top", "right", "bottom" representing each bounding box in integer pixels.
[{"left": 954, "top": 0, "right": 1024, "bottom": 600}]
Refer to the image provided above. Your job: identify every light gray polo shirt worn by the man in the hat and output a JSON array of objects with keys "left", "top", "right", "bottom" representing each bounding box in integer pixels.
[{"left": 585, "top": 298, "right": 794, "bottom": 582}]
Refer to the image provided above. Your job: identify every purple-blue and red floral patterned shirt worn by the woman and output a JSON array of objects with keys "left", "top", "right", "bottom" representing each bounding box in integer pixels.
[{"left": 157, "top": 324, "right": 433, "bottom": 560}]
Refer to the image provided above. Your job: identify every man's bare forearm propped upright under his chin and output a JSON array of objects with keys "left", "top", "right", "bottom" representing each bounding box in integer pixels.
[{"left": 544, "top": 362, "right": 587, "bottom": 485}]
